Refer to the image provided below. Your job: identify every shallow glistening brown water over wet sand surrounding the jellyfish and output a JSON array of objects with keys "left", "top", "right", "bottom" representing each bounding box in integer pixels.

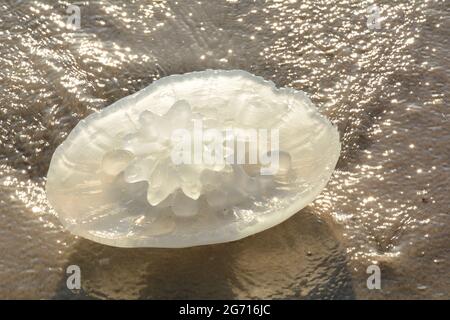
[{"left": 0, "top": 0, "right": 450, "bottom": 299}]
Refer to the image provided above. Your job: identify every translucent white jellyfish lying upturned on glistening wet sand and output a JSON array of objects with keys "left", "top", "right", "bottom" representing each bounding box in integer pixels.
[{"left": 46, "top": 70, "right": 340, "bottom": 247}]
